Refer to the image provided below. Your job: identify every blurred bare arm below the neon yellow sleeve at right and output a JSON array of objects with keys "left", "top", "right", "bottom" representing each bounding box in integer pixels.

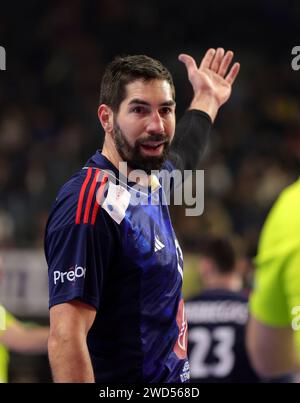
[{"left": 246, "top": 316, "right": 300, "bottom": 377}]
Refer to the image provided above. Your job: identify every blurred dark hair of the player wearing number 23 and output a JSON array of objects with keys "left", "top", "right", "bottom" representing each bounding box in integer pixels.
[{"left": 198, "top": 237, "right": 235, "bottom": 274}]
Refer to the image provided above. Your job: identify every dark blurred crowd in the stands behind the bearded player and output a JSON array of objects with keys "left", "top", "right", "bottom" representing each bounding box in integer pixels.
[{"left": 0, "top": 0, "right": 300, "bottom": 255}]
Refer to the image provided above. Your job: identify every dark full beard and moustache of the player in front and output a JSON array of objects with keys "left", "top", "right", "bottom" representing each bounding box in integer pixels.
[{"left": 113, "top": 122, "right": 170, "bottom": 175}]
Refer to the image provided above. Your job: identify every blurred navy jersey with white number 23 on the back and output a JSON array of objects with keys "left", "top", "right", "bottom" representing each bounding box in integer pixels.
[{"left": 186, "top": 290, "right": 259, "bottom": 383}]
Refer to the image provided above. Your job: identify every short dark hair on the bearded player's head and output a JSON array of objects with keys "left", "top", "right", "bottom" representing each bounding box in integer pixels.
[{"left": 99, "top": 55, "right": 175, "bottom": 112}]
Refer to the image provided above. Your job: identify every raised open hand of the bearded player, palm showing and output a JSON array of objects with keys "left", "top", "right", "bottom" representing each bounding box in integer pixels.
[{"left": 178, "top": 48, "right": 240, "bottom": 122}]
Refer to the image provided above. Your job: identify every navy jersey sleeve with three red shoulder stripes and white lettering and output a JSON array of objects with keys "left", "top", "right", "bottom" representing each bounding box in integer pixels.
[{"left": 45, "top": 168, "right": 118, "bottom": 310}]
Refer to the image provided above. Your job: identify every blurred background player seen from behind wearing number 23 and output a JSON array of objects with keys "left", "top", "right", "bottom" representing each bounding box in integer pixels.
[{"left": 186, "top": 238, "right": 259, "bottom": 383}]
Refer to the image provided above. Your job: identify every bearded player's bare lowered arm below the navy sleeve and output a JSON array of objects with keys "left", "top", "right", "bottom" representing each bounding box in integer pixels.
[{"left": 48, "top": 300, "right": 96, "bottom": 383}]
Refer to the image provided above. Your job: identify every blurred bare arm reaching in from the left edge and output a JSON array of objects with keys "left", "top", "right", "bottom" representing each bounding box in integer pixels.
[{"left": 0, "top": 320, "right": 49, "bottom": 354}]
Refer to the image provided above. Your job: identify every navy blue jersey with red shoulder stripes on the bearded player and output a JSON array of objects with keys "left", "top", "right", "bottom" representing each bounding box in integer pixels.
[{"left": 45, "top": 151, "right": 189, "bottom": 382}]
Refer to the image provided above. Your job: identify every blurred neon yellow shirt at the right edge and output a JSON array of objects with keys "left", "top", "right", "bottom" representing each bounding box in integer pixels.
[{"left": 250, "top": 180, "right": 300, "bottom": 351}]
